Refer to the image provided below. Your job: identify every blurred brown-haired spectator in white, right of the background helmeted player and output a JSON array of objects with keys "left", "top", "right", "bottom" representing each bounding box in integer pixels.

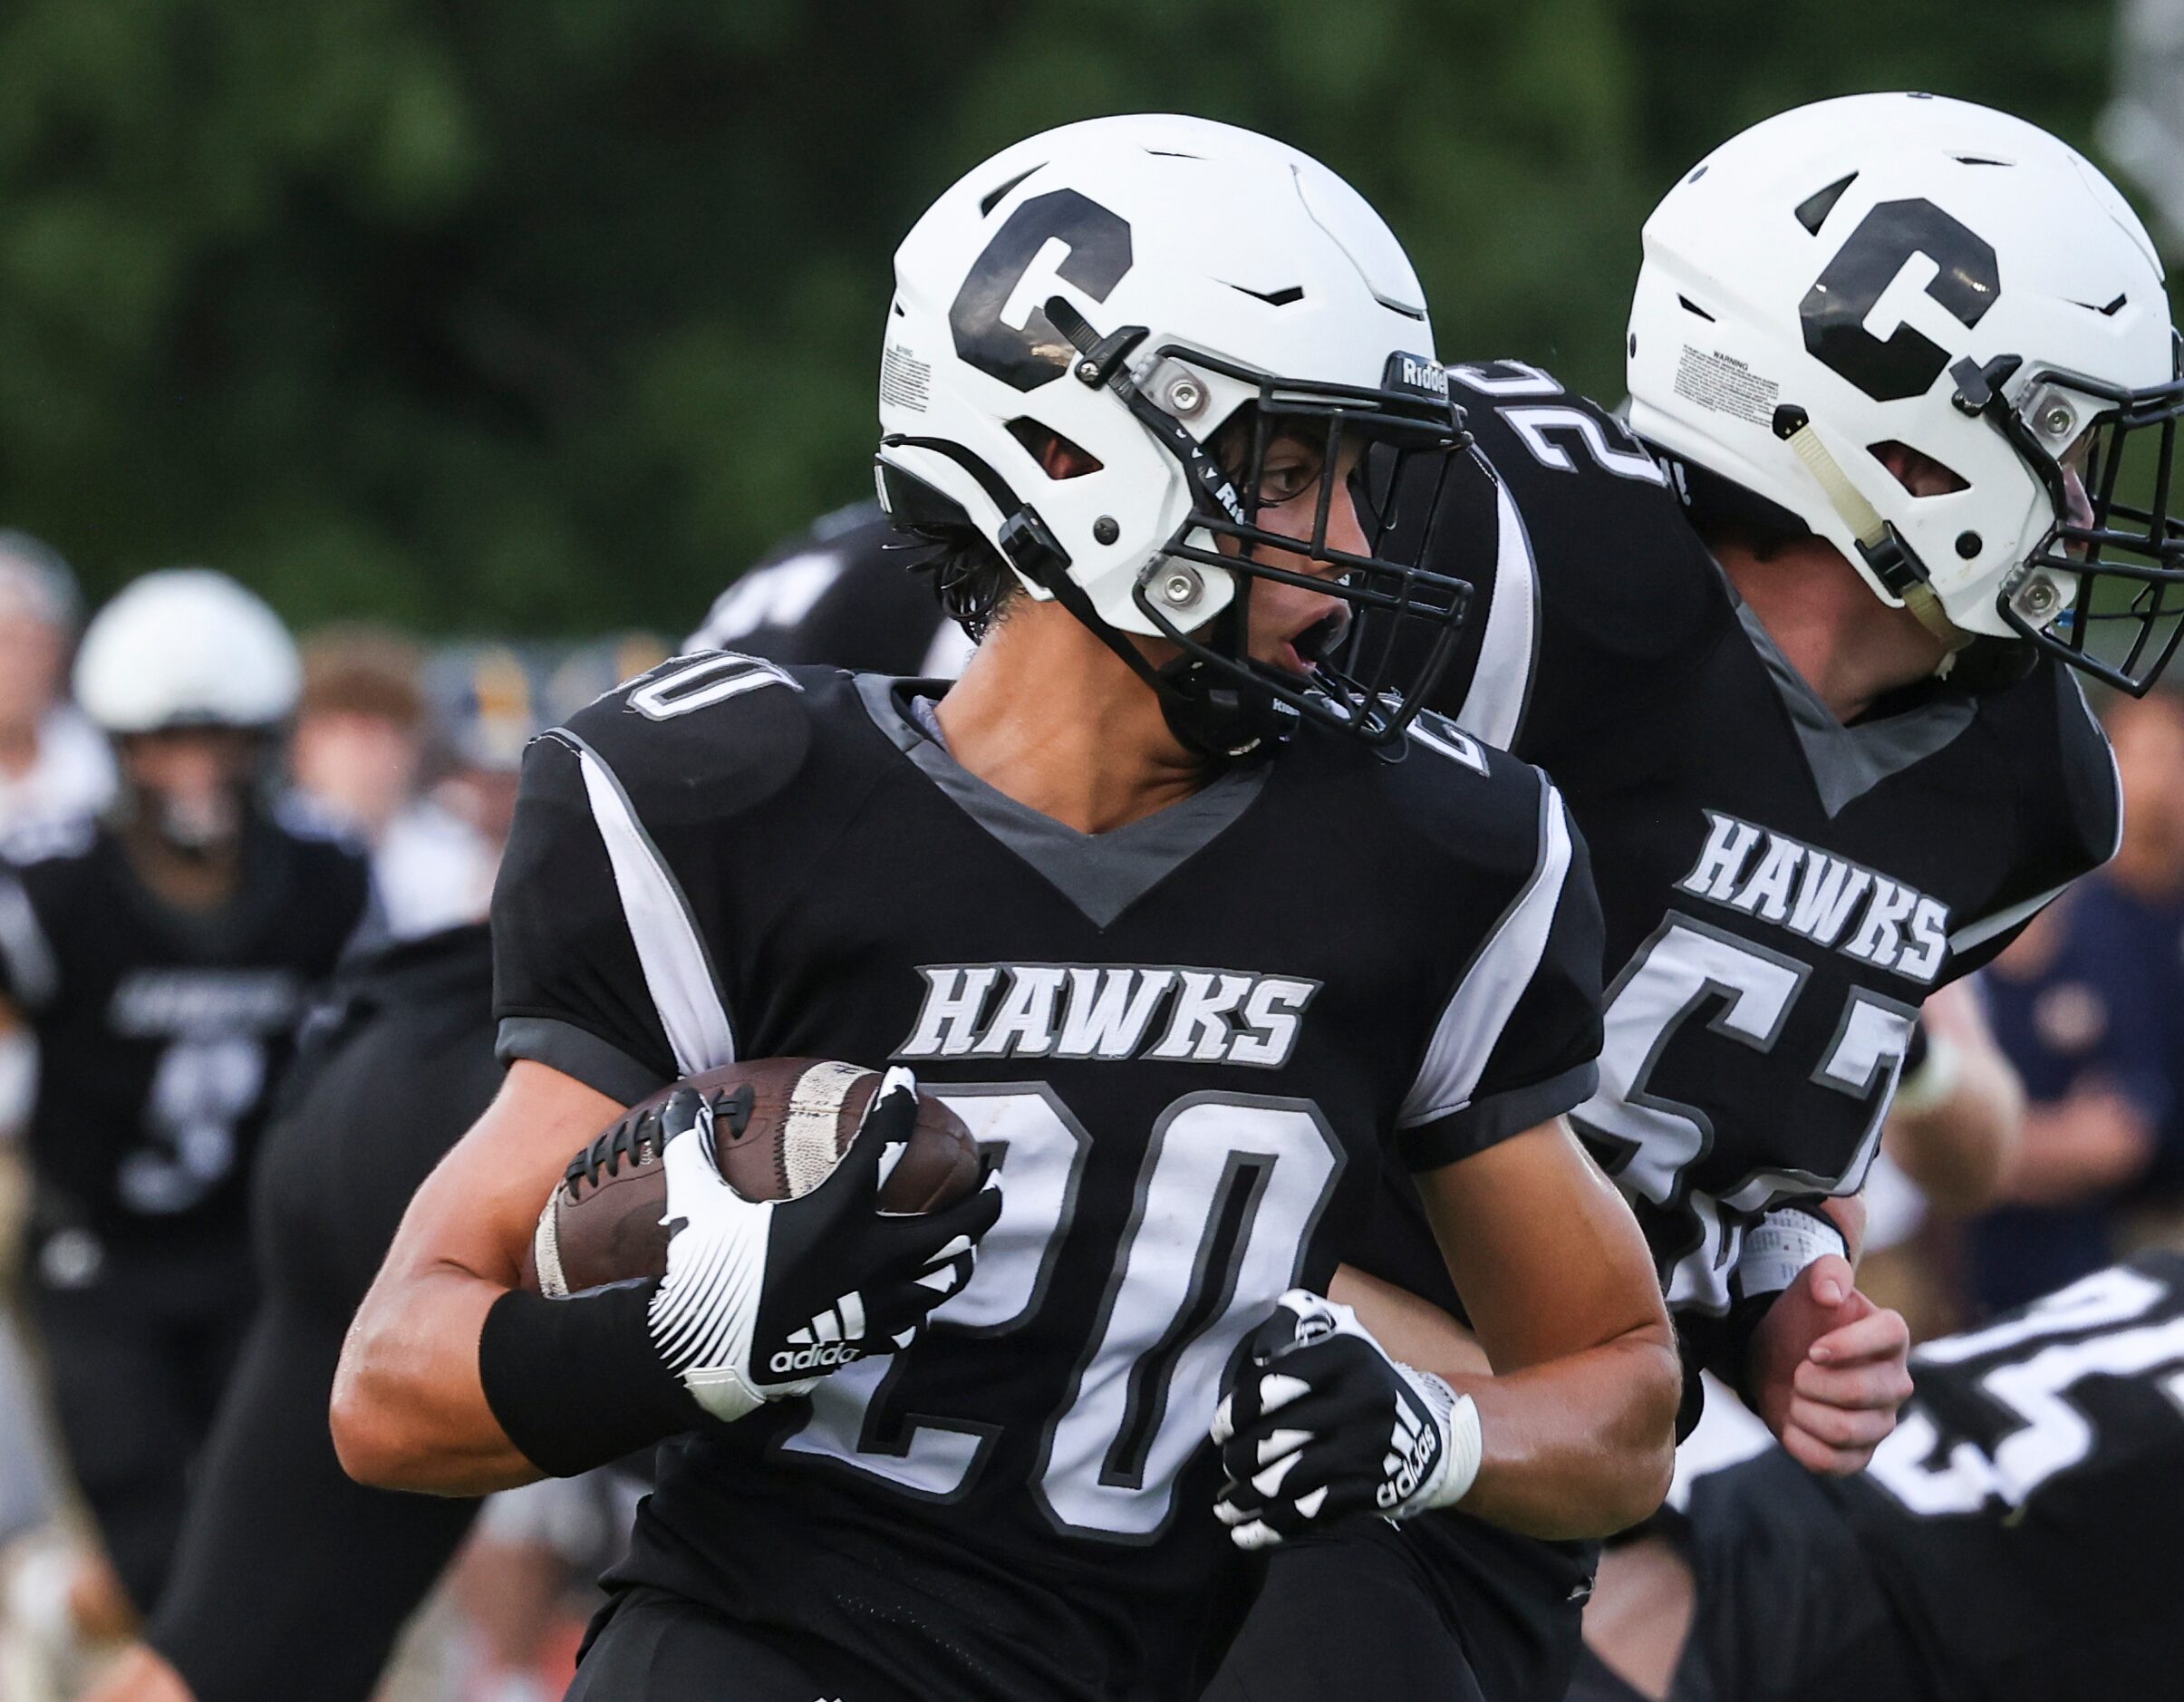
[{"left": 291, "top": 627, "right": 498, "bottom": 940}]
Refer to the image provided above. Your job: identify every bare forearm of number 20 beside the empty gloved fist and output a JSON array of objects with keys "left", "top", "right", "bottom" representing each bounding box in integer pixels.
[{"left": 1448, "top": 1324, "right": 1684, "bottom": 1541}]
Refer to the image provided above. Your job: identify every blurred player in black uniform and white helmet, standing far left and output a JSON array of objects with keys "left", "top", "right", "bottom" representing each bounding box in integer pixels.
[{"left": 0, "top": 568, "right": 369, "bottom": 1687}]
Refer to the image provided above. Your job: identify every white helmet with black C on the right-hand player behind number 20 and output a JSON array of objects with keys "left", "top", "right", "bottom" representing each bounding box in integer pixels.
[{"left": 1629, "top": 94, "right": 2184, "bottom": 692}]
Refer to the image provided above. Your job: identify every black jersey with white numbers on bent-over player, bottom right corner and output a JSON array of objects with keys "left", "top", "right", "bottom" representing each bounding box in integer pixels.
[{"left": 1675, "top": 1252, "right": 2184, "bottom": 1702}]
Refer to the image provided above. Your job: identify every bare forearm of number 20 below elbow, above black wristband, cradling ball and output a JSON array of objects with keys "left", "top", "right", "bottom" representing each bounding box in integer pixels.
[{"left": 332, "top": 1267, "right": 542, "bottom": 1494}]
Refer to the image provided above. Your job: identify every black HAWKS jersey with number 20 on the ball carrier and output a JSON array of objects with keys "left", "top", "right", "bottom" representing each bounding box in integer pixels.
[{"left": 494, "top": 653, "right": 1599, "bottom": 1697}]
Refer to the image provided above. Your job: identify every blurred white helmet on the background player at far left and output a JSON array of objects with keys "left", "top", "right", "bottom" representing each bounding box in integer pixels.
[{"left": 76, "top": 568, "right": 304, "bottom": 734}]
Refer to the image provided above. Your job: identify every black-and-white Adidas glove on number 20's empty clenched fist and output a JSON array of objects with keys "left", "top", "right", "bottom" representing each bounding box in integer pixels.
[{"left": 1213, "top": 1289, "right": 1481, "bottom": 1549}]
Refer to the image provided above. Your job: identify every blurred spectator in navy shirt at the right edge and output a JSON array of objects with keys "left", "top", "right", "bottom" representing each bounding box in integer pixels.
[{"left": 1966, "top": 692, "right": 2184, "bottom": 1310}]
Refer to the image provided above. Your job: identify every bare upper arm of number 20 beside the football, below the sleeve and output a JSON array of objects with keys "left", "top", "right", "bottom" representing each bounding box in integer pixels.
[{"left": 382, "top": 1062, "right": 624, "bottom": 1289}]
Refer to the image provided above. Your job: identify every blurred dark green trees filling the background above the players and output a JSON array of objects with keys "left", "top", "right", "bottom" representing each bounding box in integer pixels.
[{"left": 0, "top": 0, "right": 2110, "bottom": 632}]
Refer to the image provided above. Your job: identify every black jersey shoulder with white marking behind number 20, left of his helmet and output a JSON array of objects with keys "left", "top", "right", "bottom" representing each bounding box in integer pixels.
[{"left": 688, "top": 502, "right": 971, "bottom": 680}]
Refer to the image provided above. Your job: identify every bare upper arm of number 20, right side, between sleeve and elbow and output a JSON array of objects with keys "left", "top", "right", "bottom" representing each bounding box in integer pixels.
[{"left": 1417, "top": 1117, "right": 1668, "bottom": 1374}]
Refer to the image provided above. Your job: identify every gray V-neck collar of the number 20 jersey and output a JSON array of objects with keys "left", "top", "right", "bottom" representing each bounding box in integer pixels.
[{"left": 856, "top": 675, "right": 1273, "bottom": 929}]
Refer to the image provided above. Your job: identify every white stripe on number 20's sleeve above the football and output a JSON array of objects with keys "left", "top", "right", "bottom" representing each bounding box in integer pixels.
[{"left": 555, "top": 728, "right": 736, "bottom": 1075}]
